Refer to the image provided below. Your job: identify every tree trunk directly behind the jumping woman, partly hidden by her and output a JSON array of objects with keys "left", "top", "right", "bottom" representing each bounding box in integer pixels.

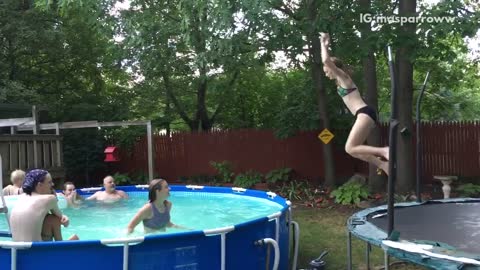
[{"left": 359, "top": 0, "right": 386, "bottom": 192}]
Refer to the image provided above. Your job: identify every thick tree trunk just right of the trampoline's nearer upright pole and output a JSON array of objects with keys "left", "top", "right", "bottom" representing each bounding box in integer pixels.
[{"left": 396, "top": 0, "right": 416, "bottom": 193}]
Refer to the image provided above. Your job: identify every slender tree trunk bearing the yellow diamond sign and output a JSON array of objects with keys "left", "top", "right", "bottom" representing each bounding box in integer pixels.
[{"left": 306, "top": 0, "right": 336, "bottom": 187}]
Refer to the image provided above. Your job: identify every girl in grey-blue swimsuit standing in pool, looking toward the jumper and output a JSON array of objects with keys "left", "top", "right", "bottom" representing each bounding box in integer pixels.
[{"left": 127, "top": 179, "right": 184, "bottom": 234}]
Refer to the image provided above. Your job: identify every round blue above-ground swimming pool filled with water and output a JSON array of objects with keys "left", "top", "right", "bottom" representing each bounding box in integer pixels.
[{"left": 0, "top": 186, "right": 292, "bottom": 270}]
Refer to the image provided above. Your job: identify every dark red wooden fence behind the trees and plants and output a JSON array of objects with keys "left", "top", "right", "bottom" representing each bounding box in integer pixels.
[{"left": 117, "top": 122, "right": 480, "bottom": 185}]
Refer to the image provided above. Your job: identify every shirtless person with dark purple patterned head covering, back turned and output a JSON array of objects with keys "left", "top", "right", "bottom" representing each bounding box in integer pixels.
[{"left": 10, "top": 170, "right": 70, "bottom": 242}]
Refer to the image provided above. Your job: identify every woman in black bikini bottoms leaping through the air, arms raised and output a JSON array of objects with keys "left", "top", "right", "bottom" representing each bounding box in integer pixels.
[{"left": 321, "top": 33, "right": 389, "bottom": 174}]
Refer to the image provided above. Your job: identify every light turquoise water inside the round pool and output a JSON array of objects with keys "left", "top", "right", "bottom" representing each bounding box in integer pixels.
[{"left": 0, "top": 192, "right": 282, "bottom": 240}]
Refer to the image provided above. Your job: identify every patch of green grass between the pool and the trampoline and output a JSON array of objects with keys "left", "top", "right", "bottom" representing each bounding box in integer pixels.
[{"left": 292, "top": 206, "right": 426, "bottom": 270}]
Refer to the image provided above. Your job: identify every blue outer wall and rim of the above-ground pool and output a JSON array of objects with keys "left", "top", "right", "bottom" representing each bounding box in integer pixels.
[{"left": 0, "top": 186, "right": 290, "bottom": 270}]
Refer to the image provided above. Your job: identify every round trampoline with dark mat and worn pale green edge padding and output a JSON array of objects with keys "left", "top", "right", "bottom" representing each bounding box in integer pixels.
[{"left": 348, "top": 199, "right": 480, "bottom": 269}]
